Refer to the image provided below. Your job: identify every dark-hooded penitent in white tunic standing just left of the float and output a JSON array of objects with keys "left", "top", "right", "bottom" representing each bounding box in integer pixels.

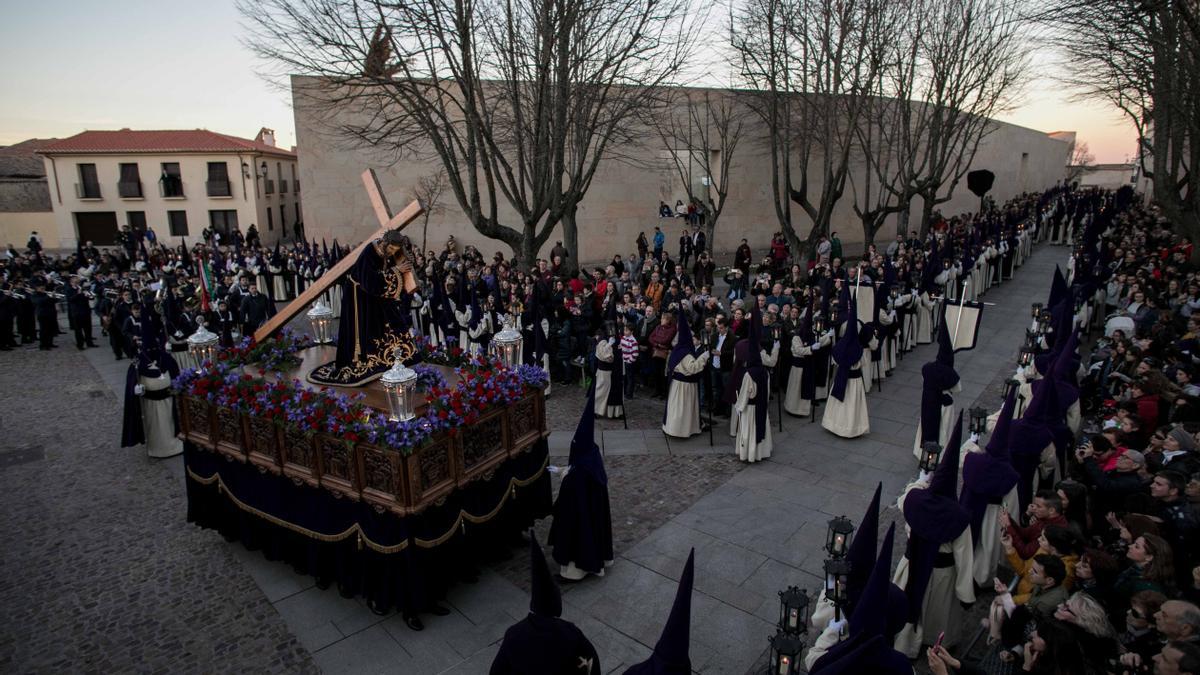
[{"left": 121, "top": 319, "right": 184, "bottom": 458}]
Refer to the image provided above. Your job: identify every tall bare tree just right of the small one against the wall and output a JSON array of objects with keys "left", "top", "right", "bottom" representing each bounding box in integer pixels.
[{"left": 731, "top": 0, "right": 893, "bottom": 256}]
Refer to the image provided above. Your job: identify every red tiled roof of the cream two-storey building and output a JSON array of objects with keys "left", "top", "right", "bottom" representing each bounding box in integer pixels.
[{"left": 38, "top": 129, "right": 296, "bottom": 157}]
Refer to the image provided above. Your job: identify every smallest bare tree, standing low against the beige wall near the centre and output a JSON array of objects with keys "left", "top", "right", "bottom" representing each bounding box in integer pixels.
[{"left": 650, "top": 89, "right": 744, "bottom": 247}]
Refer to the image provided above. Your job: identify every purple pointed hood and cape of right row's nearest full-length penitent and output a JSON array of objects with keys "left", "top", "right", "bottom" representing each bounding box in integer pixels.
[{"left": 904, "top": 412, "right": 971, "bottom": 623}]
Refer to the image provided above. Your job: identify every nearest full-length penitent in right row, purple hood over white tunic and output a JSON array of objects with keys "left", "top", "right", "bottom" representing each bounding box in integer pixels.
[{"left": 893, "top": 413, "right": 974, "bottom": 658}]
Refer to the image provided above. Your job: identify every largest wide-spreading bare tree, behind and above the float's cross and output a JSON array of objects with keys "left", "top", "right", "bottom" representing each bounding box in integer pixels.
[{"left": 240, "top": 0, "right": 704, "bottom": 264}]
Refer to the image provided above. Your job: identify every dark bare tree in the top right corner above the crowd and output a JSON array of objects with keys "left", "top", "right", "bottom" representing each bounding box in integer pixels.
[{"left": 1036, "top": 0, "right": 1200, "bottom": 239}]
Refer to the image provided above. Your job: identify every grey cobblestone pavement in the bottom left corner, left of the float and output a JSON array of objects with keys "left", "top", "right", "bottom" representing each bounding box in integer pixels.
[{"left": 0, "top": 336, "right": 316, "bottom": 673}]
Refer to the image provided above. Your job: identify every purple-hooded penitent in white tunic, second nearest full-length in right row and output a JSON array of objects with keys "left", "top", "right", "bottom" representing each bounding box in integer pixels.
[{"left": 959, "top": 390, "right": 1020, "bottom": 586}]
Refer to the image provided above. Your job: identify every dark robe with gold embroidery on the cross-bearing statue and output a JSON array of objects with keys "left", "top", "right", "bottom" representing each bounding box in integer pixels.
[{"left": 308, "top": 245, "right": 416, "bottom": 387}]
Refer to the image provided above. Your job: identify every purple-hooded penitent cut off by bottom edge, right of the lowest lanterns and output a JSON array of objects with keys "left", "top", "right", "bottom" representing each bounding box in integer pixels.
[{"left": 809, "top": 522, "right": 913, "bottom": 675}]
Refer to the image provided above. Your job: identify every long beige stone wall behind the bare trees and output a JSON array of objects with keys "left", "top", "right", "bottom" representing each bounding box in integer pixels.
[{"left": 293, "top": 78, "right": 1069, "bottom": 262}]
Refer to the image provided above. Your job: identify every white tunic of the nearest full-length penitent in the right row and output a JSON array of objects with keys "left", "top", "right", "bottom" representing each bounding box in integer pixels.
[{"left": 892, "top": 482, "right": 974, "bottom": 658}]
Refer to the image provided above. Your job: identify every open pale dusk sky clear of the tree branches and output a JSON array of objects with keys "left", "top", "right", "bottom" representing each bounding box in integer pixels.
[{"left": 0, "top": 0, "right": 1135, "bottom": 163}]
